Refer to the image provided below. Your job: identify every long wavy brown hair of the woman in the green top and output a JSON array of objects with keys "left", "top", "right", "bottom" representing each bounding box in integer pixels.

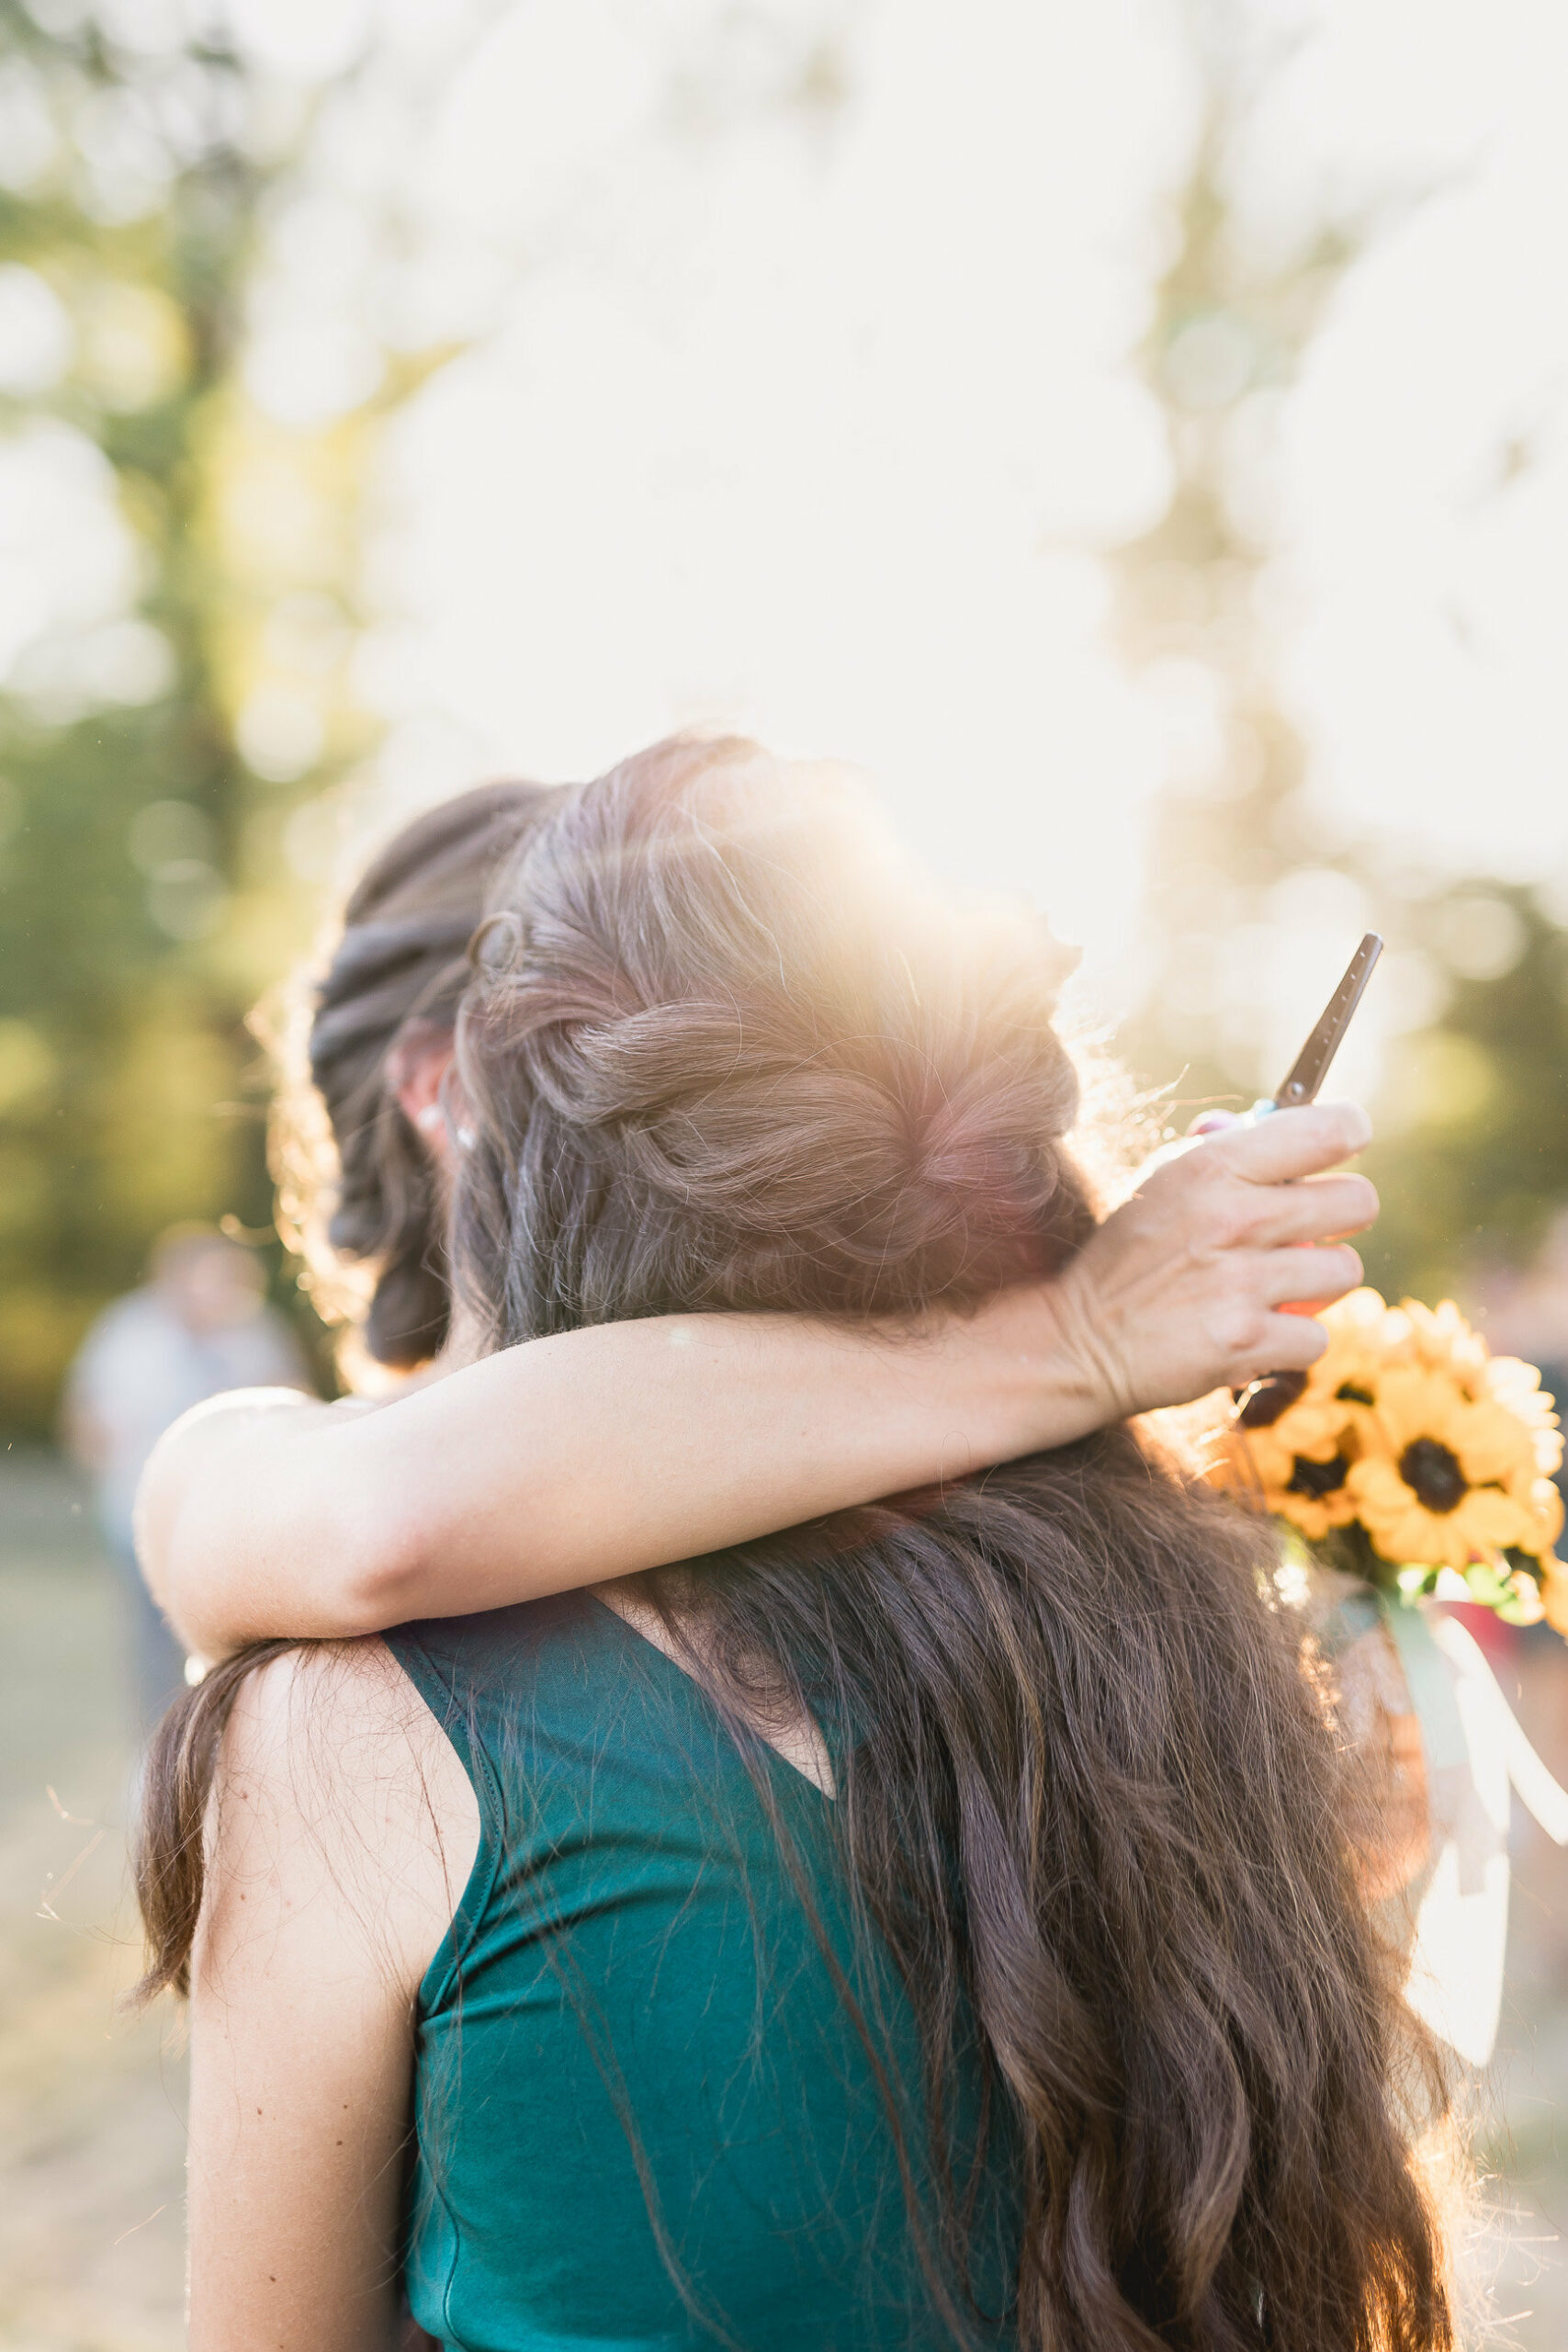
[{"left": 143, "top": 741, "right": 1453, "bottom": 2352}]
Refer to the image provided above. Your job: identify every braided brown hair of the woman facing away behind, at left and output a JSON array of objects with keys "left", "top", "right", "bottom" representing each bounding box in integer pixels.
[{"left": 275, "top": 783, "right": 562, "bottom": 1369}]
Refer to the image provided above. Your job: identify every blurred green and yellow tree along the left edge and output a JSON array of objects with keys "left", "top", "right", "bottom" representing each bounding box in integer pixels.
[{"left": 0, "top": 0, "right": 489, "bottom": 1430}]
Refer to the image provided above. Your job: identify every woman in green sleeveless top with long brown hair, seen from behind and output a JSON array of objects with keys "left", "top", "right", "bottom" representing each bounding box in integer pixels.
[{"left": 143, "top": 743, "right": 1448, "bottom": 2352}]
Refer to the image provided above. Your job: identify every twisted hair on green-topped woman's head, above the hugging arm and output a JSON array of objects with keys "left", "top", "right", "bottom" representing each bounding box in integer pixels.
[{"left": 458, "top": 741, "right": 1093, "bottom": 1345}]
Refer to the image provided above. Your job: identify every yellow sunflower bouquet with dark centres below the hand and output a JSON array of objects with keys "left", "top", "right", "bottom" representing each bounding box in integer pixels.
[{"left": 1208, "top": 1289, "right": 1568, "bottom": 1637}]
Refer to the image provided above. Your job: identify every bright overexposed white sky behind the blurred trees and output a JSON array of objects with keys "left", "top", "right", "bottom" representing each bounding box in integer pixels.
[{"left": 0, "top": 0, "right": 1568, "bottom": 1030}]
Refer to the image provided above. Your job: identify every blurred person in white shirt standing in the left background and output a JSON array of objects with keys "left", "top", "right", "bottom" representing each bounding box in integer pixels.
[{"left": 62, "top": 1226, "right": 310, "bottom": 1729}]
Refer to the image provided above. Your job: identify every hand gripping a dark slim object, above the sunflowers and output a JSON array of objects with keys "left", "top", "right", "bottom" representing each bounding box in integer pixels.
[{"left": 1054, "top": 1103, "right": 1378, "bottom": 1419}]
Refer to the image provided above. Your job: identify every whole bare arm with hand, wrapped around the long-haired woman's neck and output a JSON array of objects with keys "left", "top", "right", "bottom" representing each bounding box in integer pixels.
[{"left": 141, "top": 1105, "right": 1378, "bottom": 1656}]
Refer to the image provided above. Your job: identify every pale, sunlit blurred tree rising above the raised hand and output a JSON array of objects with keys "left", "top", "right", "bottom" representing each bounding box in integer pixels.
[{"left": 1112, "top": 64, "right": 1359, "bottom": 1108}]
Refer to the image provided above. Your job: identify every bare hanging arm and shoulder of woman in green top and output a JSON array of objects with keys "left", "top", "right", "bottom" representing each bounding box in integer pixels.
[{"left": 190, "top": 1644, "right": 478, "bottom": 2352}]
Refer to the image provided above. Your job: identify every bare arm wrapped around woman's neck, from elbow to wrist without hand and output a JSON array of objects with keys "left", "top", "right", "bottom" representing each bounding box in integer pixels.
[{"left": 141, "top": 1294, "right": 1066, "bottom": 1656}]
